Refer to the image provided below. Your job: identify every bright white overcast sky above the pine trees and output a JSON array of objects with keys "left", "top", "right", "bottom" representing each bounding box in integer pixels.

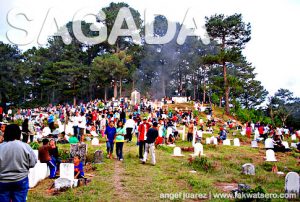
[{"left": 0, "top": 0, "right": 300, "bottom": 97}]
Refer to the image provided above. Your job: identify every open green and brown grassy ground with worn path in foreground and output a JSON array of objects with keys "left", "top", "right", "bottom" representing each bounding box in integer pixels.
[{"left": 28, "top": 137, "right": 300, "bottom": 201}]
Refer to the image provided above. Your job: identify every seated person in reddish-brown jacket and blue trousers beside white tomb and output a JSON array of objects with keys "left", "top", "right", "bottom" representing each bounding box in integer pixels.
[{"left": 39, "top": 138, "right": 57, "bottom": 179}]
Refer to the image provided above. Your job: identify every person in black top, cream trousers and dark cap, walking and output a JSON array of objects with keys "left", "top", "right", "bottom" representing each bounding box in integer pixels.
[{"left": 142, "top": 122, "right": 158, "bottom": 165}]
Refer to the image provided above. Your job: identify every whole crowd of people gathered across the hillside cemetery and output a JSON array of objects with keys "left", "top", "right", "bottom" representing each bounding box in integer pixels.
[{"left": 0, "top": 100, "right": 300, "bottom": 201}]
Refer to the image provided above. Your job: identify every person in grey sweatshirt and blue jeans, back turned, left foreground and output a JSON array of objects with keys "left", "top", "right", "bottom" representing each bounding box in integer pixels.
[{"left": 0, "top": 124, "right": 37, "bottom": 202}]
